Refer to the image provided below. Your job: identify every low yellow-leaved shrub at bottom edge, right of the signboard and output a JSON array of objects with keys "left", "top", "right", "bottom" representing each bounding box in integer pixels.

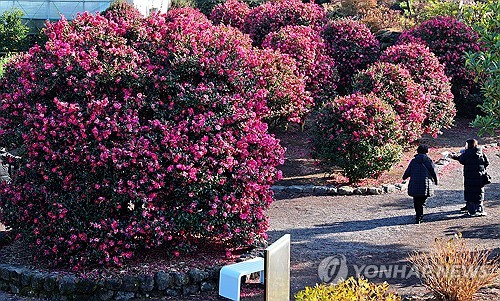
[{"left": 295, "top": 277, "right": 401, "bottom": 301}]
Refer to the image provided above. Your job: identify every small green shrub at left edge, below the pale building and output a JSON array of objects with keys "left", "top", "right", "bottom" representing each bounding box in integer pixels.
[{"left": 0, "top": 9, "right": 29, "bottom": 52}]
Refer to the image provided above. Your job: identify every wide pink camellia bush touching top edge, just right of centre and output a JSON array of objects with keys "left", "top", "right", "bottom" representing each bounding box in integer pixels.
[{"left": 243, "top": 0, "right": 326, "bottom": 46}]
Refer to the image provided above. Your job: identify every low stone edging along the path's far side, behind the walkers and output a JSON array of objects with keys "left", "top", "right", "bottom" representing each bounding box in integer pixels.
[{"left": 271, "top": 143, "right": 498, "bottom": 196}]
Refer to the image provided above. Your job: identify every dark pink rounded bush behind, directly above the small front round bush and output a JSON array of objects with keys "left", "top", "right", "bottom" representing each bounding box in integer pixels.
[{"left": 322, "top": 19, "right": 380, "bottom": 95}]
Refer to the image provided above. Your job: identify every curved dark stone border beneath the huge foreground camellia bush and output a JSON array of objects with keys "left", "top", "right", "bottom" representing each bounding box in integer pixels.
[{"left": 0, "top": 264, "right": 221, "bottom": 301}]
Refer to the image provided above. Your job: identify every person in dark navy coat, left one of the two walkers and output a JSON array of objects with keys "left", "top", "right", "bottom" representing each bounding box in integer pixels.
[{"left": 403, "top": 144, "right": 438, "bottom": 224}]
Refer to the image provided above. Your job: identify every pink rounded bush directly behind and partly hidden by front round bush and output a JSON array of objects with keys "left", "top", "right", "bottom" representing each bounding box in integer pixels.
[{"left": 353, "top": 62, "right": 429, "bottom": 143}]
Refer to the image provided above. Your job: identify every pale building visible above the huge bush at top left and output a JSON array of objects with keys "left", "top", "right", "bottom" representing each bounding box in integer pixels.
[{"left": 0, "top": 0, "right": 171, "bottom": 30}]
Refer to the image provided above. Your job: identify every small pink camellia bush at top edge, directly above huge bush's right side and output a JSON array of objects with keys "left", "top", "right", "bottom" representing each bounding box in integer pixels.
[{"left": 210, "top": 0, "right": 250, "bottom": 29}]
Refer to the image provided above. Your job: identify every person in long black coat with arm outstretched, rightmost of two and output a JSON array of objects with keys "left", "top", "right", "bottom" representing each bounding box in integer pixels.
[{"left": 451, "top": 139, "right": 489, "bottom": 216}]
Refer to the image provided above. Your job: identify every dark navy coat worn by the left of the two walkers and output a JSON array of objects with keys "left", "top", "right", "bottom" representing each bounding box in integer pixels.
[{"left": 403, "top": 154, "right": 438, "bottom": 197}]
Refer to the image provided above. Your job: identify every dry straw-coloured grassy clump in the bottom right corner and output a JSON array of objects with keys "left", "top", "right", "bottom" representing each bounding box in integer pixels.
[{"left": 409, "top": 235, "right": 500, "bottom": 301}]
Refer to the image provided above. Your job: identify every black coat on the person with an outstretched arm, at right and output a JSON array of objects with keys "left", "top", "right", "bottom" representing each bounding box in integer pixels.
[{"left": 452, "top": 148, "right": 490, "bottom": 202}]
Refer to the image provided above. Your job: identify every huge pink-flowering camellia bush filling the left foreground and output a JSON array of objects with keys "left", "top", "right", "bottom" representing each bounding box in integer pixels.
[{"left": 0, "top": 5, "right": 283, "bottom": 269}]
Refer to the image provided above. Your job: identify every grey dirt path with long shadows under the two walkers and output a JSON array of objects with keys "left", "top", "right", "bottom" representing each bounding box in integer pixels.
[{"left": 269, "top": 147, "right": 500, "bottom": 300}]
